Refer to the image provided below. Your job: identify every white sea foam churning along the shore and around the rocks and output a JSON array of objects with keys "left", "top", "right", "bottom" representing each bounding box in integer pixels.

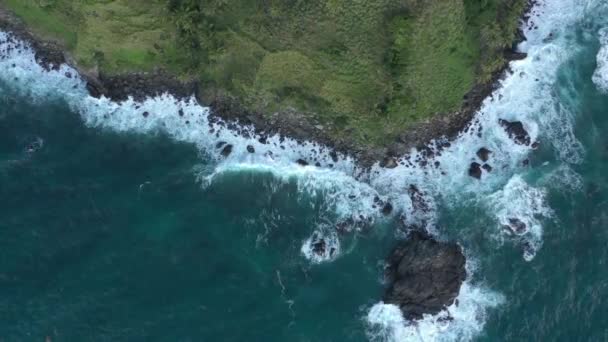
[{"left": 0, "top": 0, "right": 605, "bottom": 341}]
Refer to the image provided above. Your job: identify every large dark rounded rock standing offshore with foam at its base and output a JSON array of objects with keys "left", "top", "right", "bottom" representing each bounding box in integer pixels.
[{"left": 384, "top": 231, "right": 466, "bottom": 320}]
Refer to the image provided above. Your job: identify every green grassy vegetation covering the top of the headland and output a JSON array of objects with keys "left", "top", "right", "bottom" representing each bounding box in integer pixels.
[{"left": 4, "top": 0, "right": 525, "bottom": 145}]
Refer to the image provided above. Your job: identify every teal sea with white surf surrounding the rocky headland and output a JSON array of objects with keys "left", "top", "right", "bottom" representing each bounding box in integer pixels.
[{"left": 0, "top": 0, "right": 608, "bottom": 341}]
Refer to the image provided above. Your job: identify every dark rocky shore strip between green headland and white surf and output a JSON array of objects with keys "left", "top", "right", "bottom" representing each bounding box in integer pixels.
[{"left": 0, "top": 0, "right": 535, "bottom": 168}]
